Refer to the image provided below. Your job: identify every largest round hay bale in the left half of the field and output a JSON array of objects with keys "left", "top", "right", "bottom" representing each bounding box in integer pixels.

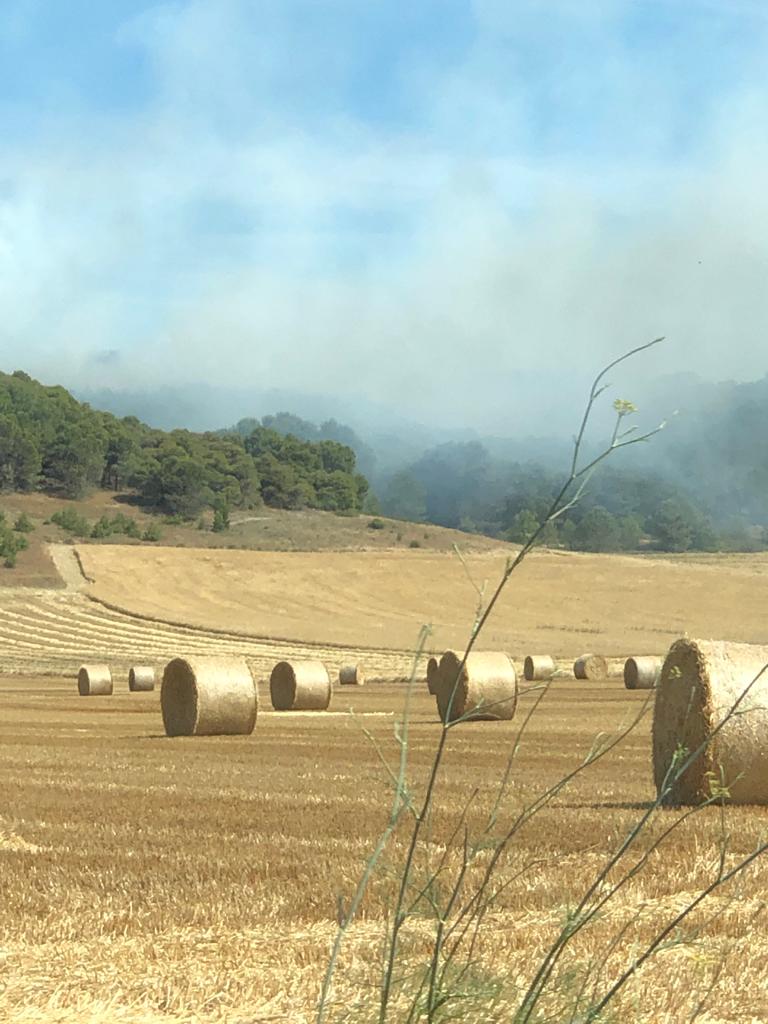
[{"left": 160, "top": 657, "right": 258, "bottom": 736}]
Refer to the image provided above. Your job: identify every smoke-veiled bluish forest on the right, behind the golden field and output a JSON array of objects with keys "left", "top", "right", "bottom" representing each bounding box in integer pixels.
[{"left": 257, "top": 405, "right": 768, "bottom": 552}]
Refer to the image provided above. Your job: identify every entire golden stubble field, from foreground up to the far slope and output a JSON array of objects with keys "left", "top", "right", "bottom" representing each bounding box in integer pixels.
[{"left": 0, "top": 548, "right": 768, "bottom": 1024}]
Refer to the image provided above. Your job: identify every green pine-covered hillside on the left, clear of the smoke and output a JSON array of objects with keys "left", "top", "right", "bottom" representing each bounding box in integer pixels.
[{"left": 0, "top": 371, "right": 369, "bottom": 517}]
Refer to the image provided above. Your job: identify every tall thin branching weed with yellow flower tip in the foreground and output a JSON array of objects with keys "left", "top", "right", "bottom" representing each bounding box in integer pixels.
[{"left": 315, "top": 338, "right": 768, "bottom": 1024}]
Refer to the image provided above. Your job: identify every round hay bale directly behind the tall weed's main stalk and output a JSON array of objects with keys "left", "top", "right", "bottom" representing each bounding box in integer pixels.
[{"left": 433, "top": 650, "right": 517, "bottom": 722}]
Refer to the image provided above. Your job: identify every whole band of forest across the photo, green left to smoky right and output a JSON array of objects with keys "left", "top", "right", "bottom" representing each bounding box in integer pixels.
[{"left": 6, "top": 372, "right": 768, "bottom": 551}]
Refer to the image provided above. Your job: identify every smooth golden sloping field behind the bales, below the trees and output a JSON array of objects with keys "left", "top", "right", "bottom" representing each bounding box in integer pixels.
[{"left": 78, "top": 546, "right": 768, "bottom": 662}]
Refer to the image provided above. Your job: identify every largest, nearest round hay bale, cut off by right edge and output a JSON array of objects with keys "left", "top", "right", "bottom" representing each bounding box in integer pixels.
[{"left": 653, "top": 639, "right": 768, "bottom": 806}]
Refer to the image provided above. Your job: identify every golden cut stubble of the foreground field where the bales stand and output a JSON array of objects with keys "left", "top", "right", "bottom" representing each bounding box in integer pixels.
[{"left": 0, "top": 678, "right": 768, "bottom": 1024}]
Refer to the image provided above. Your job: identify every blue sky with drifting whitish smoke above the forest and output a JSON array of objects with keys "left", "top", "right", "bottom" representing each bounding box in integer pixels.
[{"left": 0, "top": 0, "right": 768, "bottom": 432}]
